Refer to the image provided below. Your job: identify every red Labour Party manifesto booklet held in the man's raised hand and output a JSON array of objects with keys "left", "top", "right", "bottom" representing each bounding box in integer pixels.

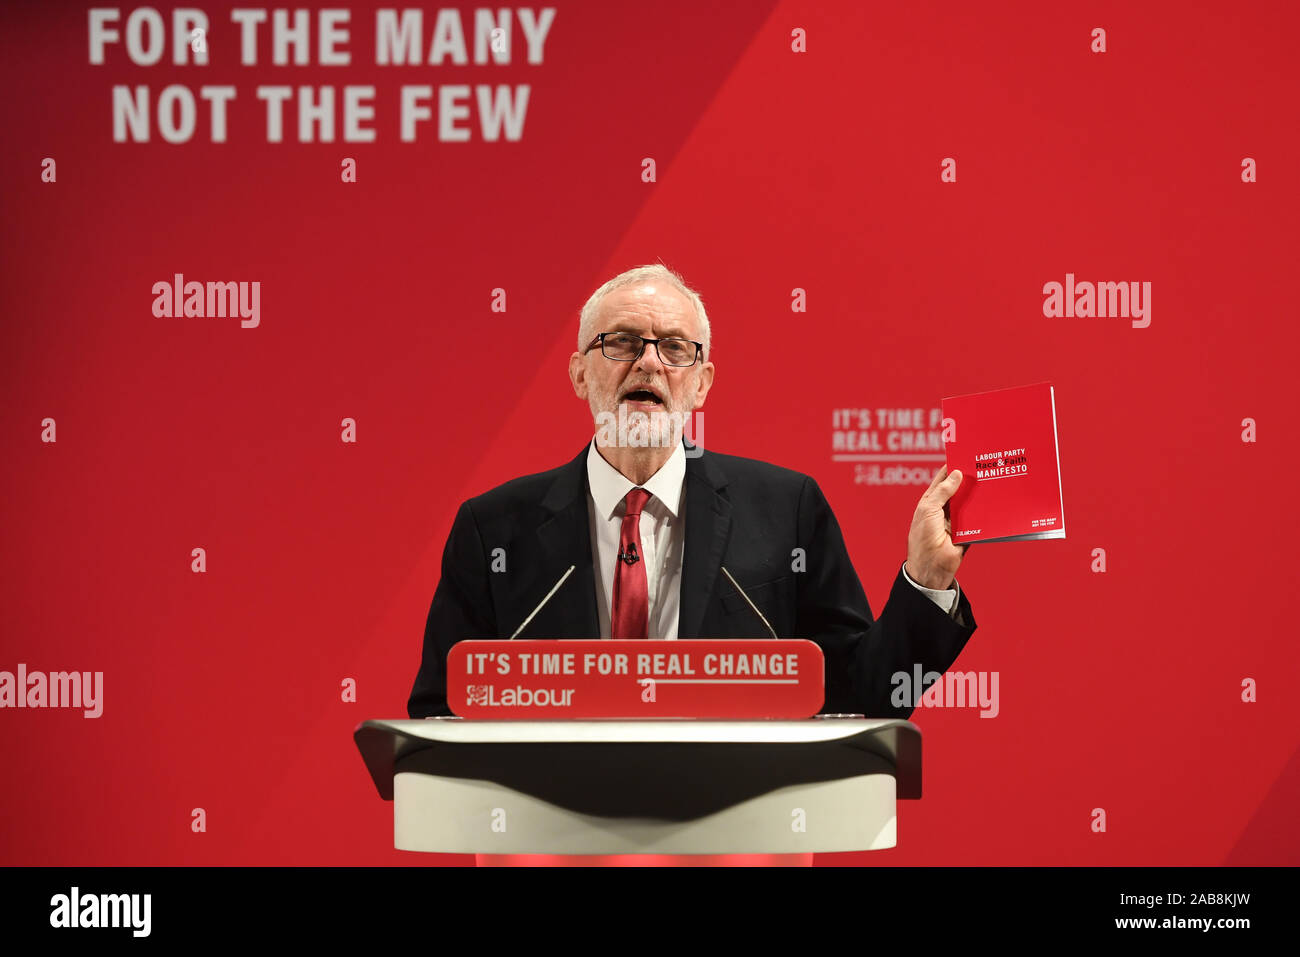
[{"left": 944, "top": 382, "right": 1065, "bottom": 545}]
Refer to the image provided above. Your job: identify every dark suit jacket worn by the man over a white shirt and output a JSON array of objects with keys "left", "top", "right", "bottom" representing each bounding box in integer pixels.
[{"left": 407, "top": 446, "right": 975, "bottom": 718}]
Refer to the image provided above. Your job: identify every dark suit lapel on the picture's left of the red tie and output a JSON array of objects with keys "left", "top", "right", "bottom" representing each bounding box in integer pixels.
[{"left": 525, "top": 446, "right": 601, "bottom": 638}]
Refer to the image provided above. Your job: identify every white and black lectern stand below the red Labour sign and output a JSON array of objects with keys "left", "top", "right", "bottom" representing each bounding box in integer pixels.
[{"left": 354, "top": 715, "right": 920, "bottom": 856}]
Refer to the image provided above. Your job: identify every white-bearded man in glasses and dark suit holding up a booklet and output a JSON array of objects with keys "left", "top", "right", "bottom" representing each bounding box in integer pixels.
[{"left": 407, "top": 265, "right": 975, "bottom": 718}]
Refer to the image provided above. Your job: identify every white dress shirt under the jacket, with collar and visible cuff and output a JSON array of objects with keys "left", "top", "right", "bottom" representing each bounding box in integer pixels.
[{"left": 586, "top": 438, "right": 959, "bottom": 638}]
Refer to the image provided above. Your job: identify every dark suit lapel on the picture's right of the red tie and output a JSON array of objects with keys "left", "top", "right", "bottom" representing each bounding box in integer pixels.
[{"left": 677, "top": 446, "right": 732, "bottom": 638}]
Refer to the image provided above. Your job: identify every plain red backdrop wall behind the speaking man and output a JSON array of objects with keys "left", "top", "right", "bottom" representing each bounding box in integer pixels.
[{"left": 0, "top": 1, "right": 1300, "bottom": 865}]
